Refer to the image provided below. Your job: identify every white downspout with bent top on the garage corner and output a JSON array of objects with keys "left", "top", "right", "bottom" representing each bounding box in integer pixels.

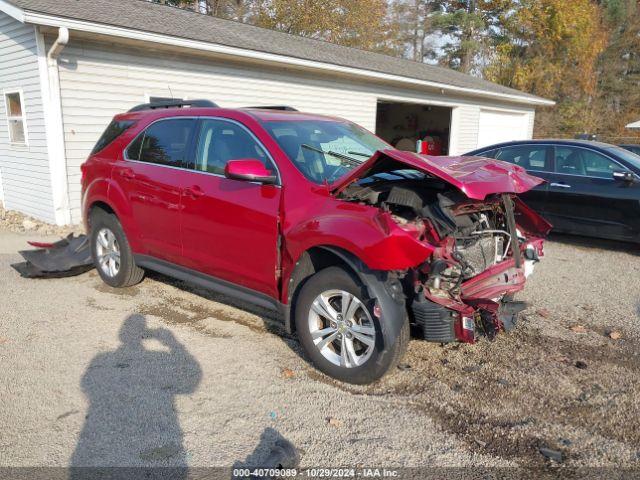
[{"left": 40, "top": 27, "right": 72, "bottom": 225}]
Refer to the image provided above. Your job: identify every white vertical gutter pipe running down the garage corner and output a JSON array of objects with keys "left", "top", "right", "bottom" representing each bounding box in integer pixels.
[{"left": 36, "top": 27, "right": 71, "bottom": 225}]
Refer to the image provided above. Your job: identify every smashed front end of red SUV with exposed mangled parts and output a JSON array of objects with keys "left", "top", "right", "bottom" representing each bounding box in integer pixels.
[{"left": 410, "top": 194, "right": 551, "bottom": 343}]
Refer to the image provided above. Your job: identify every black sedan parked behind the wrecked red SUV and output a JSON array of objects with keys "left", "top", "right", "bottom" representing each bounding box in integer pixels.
[{"left": 465, "top": 140, "right": 640, "bottom": 242}]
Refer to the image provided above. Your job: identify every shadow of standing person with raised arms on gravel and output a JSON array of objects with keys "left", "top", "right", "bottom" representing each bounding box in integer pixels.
[{"left": 70, "top": 315, "right": 202, "bottom": 479}]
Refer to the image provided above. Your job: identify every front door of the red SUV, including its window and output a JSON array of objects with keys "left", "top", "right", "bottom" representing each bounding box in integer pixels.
[{"left": 181, "top": 118, "right": 281, "bottom": 297}]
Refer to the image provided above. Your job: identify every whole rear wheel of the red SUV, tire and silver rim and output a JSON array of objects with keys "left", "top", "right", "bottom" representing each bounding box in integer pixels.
[{"left": 91, "top": 209, "right": 144, "bottom": 288}]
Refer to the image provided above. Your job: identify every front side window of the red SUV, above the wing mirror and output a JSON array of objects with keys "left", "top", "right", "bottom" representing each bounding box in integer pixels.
[{"left": 195, "top": 119, "right": 275, "bottom": 175}]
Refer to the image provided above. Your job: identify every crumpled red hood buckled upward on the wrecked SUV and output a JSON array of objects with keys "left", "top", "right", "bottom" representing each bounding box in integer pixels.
[{"left": 330, "top": 149, "right": 544, "bottom": 200}]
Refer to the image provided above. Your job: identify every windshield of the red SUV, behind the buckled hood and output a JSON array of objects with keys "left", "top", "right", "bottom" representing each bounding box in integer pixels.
[{"left": 263, "top": 120, "right": 391, "bottom": 183}]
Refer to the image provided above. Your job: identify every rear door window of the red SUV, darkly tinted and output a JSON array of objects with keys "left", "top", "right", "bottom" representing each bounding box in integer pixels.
[{"left": 127, "top": 118, "right": 195, "bottom": 167}]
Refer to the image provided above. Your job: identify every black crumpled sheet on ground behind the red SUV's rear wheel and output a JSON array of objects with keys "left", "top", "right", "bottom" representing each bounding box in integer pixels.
[{"left": 11, "top": 234, "right": 93, "bottom": 278}]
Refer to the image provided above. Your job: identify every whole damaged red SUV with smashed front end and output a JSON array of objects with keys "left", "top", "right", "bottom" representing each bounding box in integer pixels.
[{"left": 82, "top": 101, "right": 550, "bottom": 384}]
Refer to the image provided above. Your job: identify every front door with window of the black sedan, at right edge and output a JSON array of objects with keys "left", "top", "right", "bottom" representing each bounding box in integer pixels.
[{"left": 547, "top": 145, "right": 640, "bottom": 239}]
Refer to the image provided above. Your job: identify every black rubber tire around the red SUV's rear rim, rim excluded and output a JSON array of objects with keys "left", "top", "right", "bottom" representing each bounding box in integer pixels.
[{"left": 90, "top": 209, "right": 144, "bottom": 288}]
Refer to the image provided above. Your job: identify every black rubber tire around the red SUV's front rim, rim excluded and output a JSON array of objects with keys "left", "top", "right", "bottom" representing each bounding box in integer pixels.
[{"left": 294, "top": 267, "right": 410, "bottom": 385}]
